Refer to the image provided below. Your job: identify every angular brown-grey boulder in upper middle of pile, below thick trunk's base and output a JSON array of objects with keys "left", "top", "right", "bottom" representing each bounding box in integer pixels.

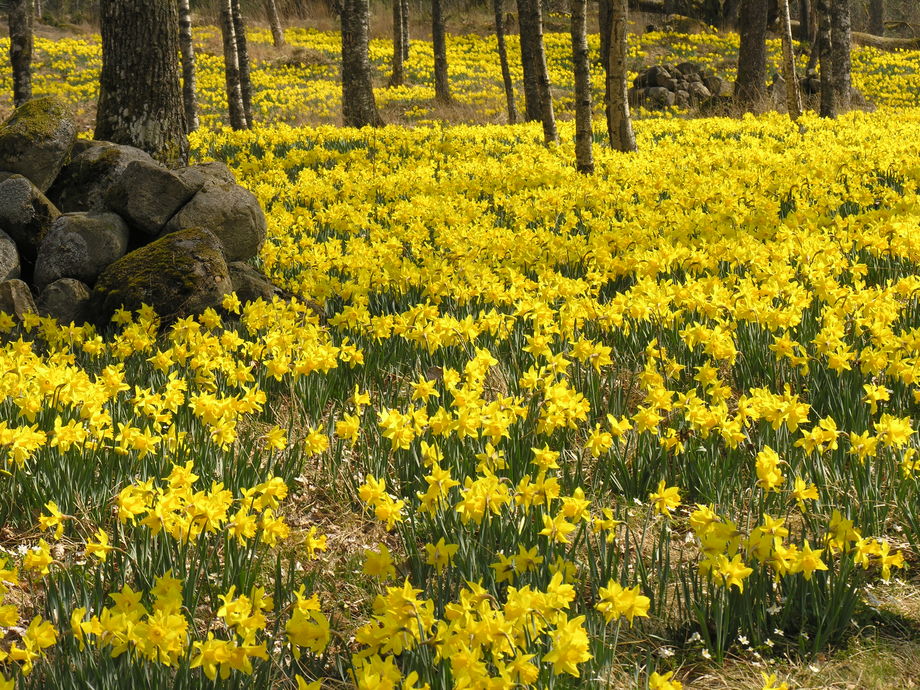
[{"left": 105, "top": 160, "right": 201, "bottom": 236}]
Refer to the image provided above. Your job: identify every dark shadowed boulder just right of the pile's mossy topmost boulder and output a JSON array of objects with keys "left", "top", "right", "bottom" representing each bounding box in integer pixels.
[{"left": 48, "top": 141, "right": 154, "bottom": 213}]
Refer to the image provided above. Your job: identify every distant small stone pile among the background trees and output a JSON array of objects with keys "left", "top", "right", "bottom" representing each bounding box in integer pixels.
[{"left": 628, "top": 62, "right": 732, "bottom": 110}]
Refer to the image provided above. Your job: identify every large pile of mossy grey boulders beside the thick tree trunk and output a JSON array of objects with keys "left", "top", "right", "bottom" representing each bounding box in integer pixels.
[{"left": 0, "top": 97, "right": 278, "bottom": 325}]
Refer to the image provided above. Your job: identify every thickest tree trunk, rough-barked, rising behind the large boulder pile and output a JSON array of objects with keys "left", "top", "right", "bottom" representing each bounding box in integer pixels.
[{"left": 94, "top": 0, "right": 188, "bottom": 166}]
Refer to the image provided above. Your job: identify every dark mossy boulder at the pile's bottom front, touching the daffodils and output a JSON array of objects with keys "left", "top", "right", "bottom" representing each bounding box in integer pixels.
[{"left": 91, "top": 228, "right": 233, "bottom": 324}]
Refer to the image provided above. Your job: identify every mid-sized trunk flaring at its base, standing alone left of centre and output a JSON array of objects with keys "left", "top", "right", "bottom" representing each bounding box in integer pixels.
[{"left": 342, "top": 0, "right": 383, "bottom": 127}]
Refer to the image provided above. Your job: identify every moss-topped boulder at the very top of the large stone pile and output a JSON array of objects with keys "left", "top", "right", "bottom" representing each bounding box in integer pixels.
[{"left": 0, "top": 96, "right": 77, "bottom": 192}]
